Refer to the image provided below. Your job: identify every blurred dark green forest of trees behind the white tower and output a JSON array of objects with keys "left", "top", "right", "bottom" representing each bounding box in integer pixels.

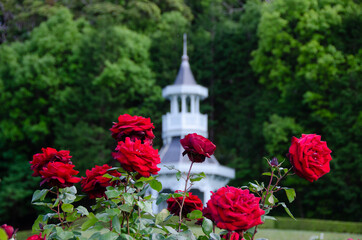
[{"left": 0, "top": 0, "right": 362, "bottom": 228}]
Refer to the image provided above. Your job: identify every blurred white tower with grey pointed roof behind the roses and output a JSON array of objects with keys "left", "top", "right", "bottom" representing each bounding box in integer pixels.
[{"left": 151, "top": 34, "right": 235, "bottom": 212}]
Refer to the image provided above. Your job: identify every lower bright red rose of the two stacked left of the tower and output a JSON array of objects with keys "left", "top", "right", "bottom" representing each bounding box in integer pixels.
[{"left": 112, "top": 138, "right": 161, "bottom": 177}]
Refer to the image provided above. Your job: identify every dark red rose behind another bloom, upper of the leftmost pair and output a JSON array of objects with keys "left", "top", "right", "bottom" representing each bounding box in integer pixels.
[{"left": 30, "top": 147, "right": 72, "bottom": 177}]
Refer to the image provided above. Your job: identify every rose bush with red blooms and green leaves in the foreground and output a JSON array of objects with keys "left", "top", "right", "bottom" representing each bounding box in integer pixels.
[{"left": 0, "top": 114, "right": 331, "bottom": 240}]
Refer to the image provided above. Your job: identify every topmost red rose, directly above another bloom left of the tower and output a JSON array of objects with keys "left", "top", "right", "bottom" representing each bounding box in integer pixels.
[{"left": 110, "top": 114, "right": 155, "bottom": 142}]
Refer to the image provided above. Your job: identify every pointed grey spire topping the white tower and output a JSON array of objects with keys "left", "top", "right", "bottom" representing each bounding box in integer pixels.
[{"left": 174, "top": 33, "right": 197, "bottom": 85}]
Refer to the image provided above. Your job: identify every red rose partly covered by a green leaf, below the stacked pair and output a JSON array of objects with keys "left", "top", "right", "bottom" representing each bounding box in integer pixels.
[{"left": 81, "top": 164, "right": 121, "bottom": 198}]
